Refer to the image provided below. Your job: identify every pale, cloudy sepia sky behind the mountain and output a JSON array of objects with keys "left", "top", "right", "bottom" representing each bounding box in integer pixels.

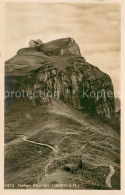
[{"left": 5, "top": 2, "right": 121, "bottom": 96}]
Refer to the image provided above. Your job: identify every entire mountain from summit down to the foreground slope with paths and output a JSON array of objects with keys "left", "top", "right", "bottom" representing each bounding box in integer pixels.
[{"left": 5, "top": 38, "right": 120, "bottom": 189}]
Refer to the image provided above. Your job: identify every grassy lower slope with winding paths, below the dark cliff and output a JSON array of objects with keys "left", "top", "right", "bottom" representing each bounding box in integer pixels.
[{"left": 5, "top": 99, "right": 120, "bottom": 189}]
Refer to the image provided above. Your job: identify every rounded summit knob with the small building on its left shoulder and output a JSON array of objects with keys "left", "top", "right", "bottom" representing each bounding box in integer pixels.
[{"left": 18, "top": 37, "right": 82, "bottom": 56}]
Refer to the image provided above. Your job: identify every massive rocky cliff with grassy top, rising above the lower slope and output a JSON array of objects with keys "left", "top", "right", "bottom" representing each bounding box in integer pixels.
[{"left": 5, "top": 38, "right": 115, "bottom": 119}]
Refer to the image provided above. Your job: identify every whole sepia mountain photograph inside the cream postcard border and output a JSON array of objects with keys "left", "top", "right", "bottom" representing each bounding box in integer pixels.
[{"left": 4, "top": 1, "right": 121, "bottom": 190}]
